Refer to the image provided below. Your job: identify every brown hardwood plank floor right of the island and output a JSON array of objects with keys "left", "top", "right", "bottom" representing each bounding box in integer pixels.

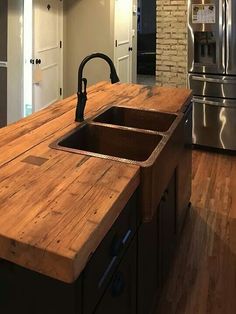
[{"left": 156, "top": 151, "right": 236, "bottom": 314}]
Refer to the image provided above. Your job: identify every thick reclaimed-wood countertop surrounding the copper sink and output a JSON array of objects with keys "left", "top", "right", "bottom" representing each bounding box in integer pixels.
[{"left": 0, "top": 82, "right": 191, "bottom": 283}]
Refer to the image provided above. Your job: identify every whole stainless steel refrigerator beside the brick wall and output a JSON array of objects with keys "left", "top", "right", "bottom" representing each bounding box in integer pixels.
[{"left": 188, "top": 0, "right": 236, "bottom": 151}]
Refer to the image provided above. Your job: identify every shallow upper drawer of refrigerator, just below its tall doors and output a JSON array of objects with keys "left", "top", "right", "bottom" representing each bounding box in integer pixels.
[{"left": 189, "top": 74, "right": 236, "bottom": 99}]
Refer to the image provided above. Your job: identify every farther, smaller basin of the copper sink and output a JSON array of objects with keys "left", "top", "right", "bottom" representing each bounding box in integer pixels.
[{"left": 93, "top": 106, "right": 177, "bottom": 132}]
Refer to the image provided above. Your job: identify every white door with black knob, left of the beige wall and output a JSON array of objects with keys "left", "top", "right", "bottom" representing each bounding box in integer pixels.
[{"left": 33, "top": 0, "right": 63, "bottom": 111}]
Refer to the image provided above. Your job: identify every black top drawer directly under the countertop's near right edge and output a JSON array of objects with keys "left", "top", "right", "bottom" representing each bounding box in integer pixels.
[{"left": 83, "top": 192, "right": 138, "bottom": 314}]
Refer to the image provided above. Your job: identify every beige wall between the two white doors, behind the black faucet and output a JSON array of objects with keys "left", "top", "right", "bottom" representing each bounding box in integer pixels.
[{"left": 63, "top": 0, "right": 114, "bottom": 97}]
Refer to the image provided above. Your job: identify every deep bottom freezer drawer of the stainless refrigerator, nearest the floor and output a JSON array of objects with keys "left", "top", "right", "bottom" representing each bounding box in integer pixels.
[{"left": 193, "top": 99, "right": 236, "bottom": 150}]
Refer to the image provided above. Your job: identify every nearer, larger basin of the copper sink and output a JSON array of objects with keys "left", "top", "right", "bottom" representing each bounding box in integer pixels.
[{"left": 51, "top": 123, "right": 163, "bottom": 163}]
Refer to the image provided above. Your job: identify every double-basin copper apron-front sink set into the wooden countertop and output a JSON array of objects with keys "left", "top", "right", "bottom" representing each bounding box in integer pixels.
[{"left": 50, "top": 106, "right": 183, "bottom": 222}]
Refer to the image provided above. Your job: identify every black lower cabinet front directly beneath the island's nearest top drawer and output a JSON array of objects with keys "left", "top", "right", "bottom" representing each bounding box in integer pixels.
[{"left": 94, "top": 238, "right": 136, "bottom": 314}]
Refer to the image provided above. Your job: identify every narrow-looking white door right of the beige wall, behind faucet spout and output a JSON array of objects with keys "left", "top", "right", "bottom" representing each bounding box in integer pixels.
[{"left": 114, "top": 0, "right": 132, "bottom": 83}]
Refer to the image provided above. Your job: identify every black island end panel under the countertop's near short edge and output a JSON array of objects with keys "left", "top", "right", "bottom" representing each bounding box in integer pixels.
[{"left": 0, "top": 259, "right": 79, "bottom": 314}]
